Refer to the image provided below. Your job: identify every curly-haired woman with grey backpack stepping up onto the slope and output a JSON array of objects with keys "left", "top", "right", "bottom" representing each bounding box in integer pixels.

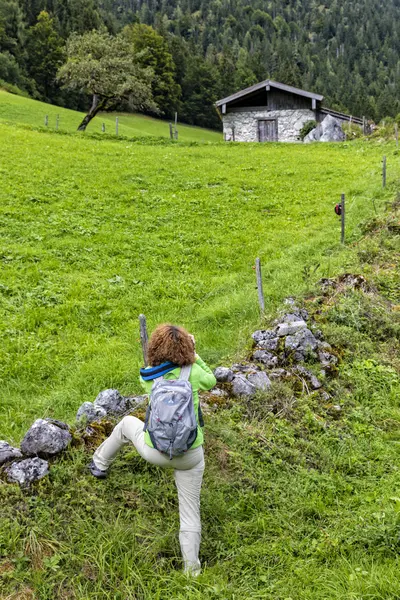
[{"left": 89, "top": 325, "right": 216, "bottom": 575}]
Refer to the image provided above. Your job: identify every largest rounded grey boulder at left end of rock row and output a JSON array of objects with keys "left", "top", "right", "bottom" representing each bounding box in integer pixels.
[{"left": 21, "top": 419, "right": 72, "bottom": 458}]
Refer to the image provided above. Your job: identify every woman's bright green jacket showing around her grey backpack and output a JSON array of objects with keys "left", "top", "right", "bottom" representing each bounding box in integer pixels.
[{"left": 140, "top": 354, "right": 217, "bottom": 448}]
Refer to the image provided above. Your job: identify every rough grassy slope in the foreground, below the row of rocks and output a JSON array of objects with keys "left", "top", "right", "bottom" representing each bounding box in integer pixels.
[{"left": 0, "top": 205, "right": 400, "bottom": 600}]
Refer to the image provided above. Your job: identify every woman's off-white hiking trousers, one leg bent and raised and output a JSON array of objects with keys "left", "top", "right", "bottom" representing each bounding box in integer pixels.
[{"left": 93, "top": 417, "right": 204, "bottom": 575}]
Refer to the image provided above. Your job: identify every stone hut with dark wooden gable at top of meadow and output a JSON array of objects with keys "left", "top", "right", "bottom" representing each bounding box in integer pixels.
[{"left": 216, "top": 79, "right": 362, "bottom": 142}]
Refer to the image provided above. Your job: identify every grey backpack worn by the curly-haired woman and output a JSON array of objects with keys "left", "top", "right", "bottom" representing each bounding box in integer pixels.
[{"left": 144, "top": 365, "right": 197, "bottom": 460}]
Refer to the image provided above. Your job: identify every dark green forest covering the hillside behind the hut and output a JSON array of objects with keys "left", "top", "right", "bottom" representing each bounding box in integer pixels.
[{"left": 0, "top": 0, "right": 400, "bottom": 129}]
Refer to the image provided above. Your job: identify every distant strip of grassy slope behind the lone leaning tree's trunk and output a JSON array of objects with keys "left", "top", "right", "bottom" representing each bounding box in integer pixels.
[{"left": 0, "top": 90, "right": 222, "bottom": 142}]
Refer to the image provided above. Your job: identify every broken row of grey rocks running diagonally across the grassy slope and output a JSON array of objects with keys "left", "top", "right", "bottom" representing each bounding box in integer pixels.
[{"left": 0, "top": 298, "right": 340, "bottom": 485}]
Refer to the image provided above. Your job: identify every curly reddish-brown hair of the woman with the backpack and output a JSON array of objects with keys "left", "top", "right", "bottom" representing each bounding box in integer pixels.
[{"left": 147, "top": 323, "right": 196, "bottom": 367}]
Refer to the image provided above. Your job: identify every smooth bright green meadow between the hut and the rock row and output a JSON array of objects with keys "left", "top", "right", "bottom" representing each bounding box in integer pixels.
[{"left": 0, "top": 125, "right": 397, "bottom": 441}]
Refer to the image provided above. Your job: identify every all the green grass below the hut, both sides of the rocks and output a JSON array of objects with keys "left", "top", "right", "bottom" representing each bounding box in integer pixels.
[{"left": 0, "top": 91, "right": 400, "bottom": 600}]
